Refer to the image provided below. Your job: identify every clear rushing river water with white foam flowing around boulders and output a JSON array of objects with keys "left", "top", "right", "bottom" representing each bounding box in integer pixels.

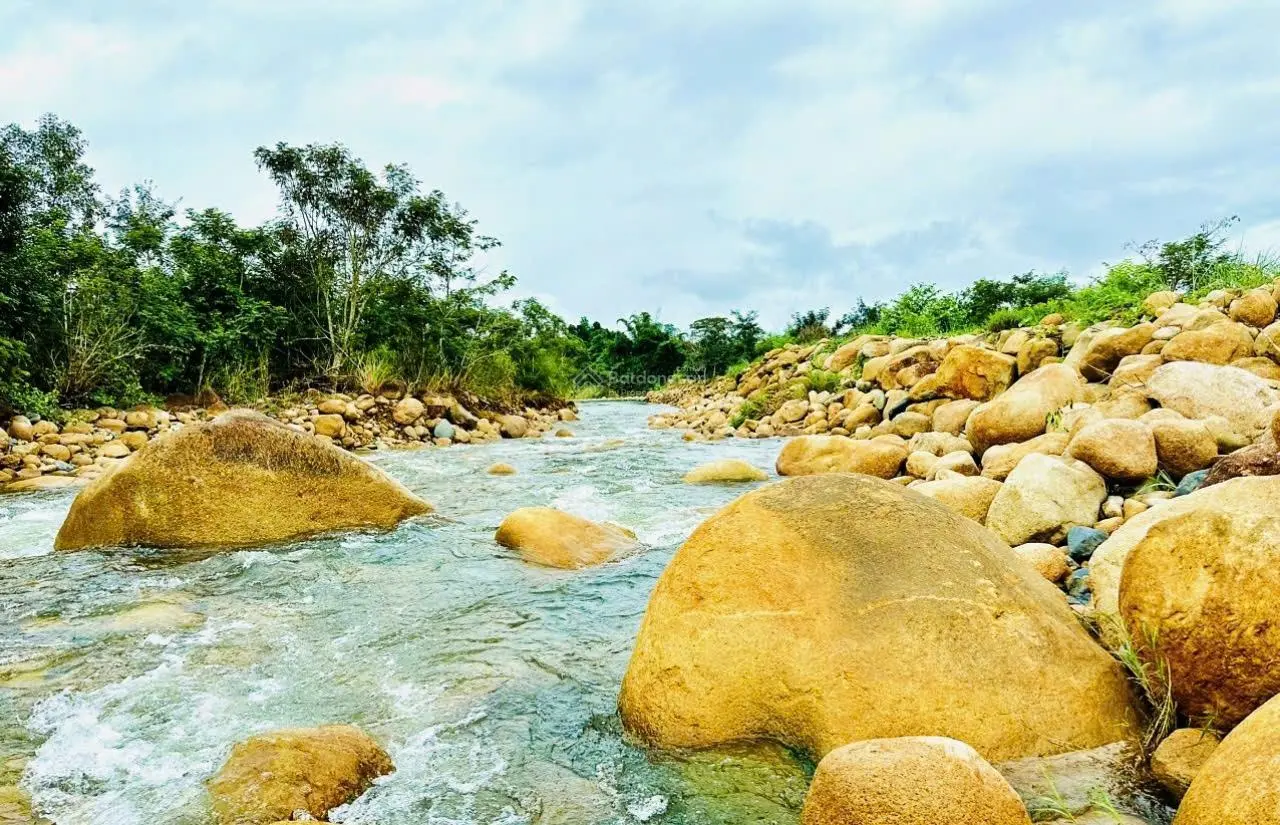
[{"left": 0, "top": 402, "right": 810, "bottom": 825}]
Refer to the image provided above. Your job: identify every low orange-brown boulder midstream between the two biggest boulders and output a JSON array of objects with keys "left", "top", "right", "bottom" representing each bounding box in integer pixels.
[{"left": 494, "top": 507, "right": 639, "bottom": 569}]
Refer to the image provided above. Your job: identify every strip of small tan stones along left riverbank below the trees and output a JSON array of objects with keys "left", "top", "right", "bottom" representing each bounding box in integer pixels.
[{"left": 0, "top": 390, "right": 577, "bottom": 492}]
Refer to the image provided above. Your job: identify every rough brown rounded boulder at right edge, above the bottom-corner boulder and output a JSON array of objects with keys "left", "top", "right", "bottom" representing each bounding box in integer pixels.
[{"left": 1120, "top": 480, "right": 1280, "bottom": 727}]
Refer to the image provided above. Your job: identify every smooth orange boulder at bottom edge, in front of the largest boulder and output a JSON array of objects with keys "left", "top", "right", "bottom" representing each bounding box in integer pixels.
[{"left": 800, "top": 737, "right": 1032, "bottom": 825}]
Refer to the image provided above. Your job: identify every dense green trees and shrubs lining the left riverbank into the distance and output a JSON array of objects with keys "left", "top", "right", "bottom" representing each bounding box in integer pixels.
[{"left": 0, "top": 115, "right": 762, "bottom": 414}]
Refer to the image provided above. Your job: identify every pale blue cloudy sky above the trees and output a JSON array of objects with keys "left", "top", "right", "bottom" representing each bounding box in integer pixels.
[{"left": 0, "top": 0, "right": 1280, "bottom": 326}]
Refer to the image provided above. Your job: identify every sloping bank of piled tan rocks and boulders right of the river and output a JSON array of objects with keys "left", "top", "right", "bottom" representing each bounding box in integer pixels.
[{"left": 650, "top": 282, "right": 1280, "bottom": 604}]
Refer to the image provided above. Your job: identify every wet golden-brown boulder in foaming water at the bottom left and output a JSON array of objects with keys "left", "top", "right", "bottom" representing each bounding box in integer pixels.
[{"left": 209, "top": 725, "right": 396, "bottom": 825}]
